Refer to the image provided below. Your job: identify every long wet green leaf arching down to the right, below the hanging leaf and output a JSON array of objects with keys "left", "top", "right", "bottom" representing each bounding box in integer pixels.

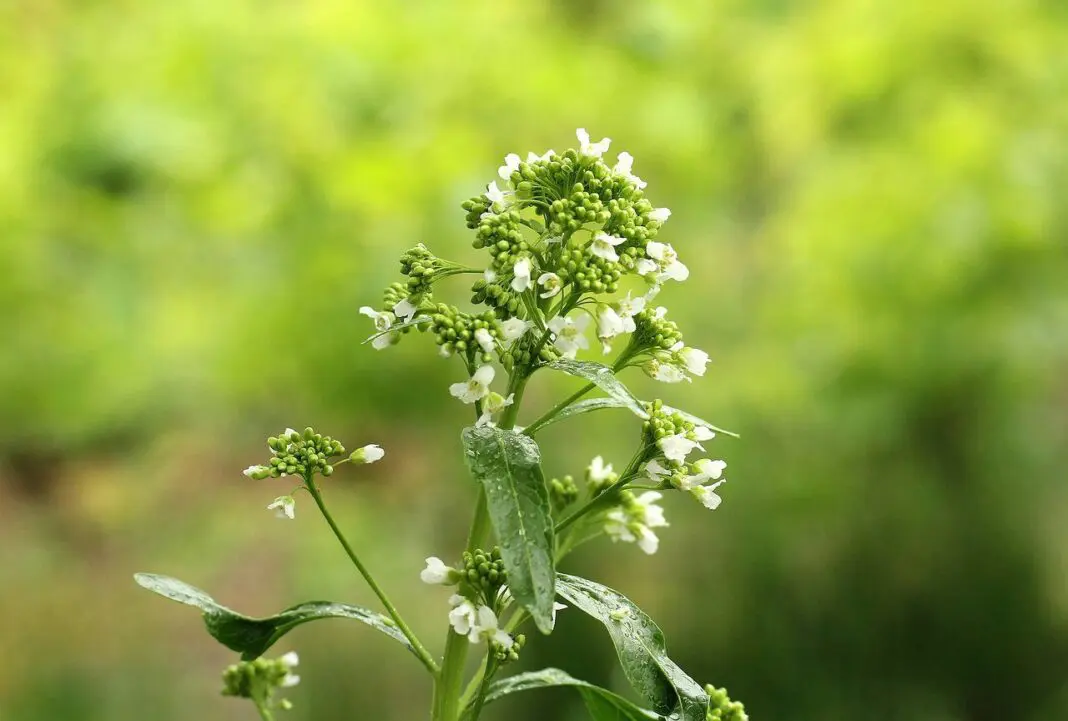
[{"left": 556, "top": 574, "right": 708, "bottom": 721}]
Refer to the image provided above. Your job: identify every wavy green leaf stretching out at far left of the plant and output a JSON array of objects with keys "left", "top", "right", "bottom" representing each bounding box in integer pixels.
[{"left": 134, "top": 574, "right": 414, "bottom": 660}]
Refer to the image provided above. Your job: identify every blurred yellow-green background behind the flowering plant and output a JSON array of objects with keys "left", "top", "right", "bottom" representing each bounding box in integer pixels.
[{"left": 0, "top": 0, "right": 1068, "bottom": 721}]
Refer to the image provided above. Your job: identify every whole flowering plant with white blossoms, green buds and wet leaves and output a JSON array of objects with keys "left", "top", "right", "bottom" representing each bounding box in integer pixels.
[{"left": 136, "top": 129, "right": 747, "bottom": 721}]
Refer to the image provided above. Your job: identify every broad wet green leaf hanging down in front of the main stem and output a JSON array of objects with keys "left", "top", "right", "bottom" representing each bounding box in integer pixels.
[{"left": 464, "top": 426, "right": 556, "bottom": 633}]
